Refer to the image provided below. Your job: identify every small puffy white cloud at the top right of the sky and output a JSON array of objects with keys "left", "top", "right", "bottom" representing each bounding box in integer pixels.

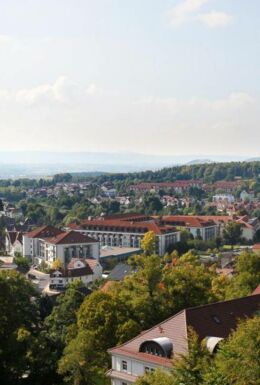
[{"left": 168, "top": 0, "right": 232, "bottom": 28}]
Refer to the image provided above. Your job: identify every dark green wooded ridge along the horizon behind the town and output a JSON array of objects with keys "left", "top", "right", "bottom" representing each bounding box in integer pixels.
[{"left": 0, "top": 161, "right": 260, "bottom": 188}]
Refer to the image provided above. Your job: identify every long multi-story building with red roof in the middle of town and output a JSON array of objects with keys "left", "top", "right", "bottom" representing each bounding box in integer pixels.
[{"left": 70, "top": 214, "right": 180, "bottom": 256}]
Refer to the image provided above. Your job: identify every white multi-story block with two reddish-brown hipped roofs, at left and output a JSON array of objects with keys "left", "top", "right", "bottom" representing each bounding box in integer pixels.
[{"left": 23, "top": 226, "right": 99, "bottom": 266}]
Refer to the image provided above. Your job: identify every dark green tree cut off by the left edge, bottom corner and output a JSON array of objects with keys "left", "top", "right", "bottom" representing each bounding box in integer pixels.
[{"left": 0, "top": 270, "right": 39, "bottom": 385}]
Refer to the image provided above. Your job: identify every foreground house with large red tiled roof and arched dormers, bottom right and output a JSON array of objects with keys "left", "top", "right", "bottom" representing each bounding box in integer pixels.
[{"left": 108, "top": 294, "right": 260, "bottom": 385}]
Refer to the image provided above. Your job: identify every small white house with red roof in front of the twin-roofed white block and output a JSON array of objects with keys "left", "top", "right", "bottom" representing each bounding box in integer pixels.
[{"left": 49, "top": 258, "right": 102, "bottom": 289}]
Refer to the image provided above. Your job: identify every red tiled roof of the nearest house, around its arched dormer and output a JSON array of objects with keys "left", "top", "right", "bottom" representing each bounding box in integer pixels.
[{"left": 109, "top": 294, "right": 260, "bottom": 367}]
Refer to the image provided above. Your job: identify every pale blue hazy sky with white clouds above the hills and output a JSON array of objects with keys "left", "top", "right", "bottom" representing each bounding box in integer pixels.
[{"left": 0, "top": 0, "right": 260, "bottom": 157}]
